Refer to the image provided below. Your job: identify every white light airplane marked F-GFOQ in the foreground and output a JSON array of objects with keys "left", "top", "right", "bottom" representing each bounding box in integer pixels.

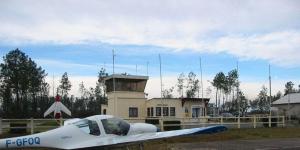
[{"left": 0, "top": 115, "right": 227, "bottom": 149}]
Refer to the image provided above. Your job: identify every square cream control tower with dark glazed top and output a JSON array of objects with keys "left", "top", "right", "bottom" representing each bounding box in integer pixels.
[{"left": 104, "top": 74, "right": 148, "bottom": 118}]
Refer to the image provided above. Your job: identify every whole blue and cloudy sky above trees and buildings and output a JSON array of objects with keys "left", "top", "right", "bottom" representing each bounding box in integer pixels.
[{"left": 0, "top": 0, "right": 300, "bottom": 99}]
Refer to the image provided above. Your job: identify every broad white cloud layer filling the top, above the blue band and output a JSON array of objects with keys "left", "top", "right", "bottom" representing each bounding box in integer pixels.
[{"left": 0, "top": 0, "right": 300, "bottom": 67}]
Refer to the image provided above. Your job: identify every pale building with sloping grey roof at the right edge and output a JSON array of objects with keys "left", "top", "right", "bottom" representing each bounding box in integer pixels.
[{"left": 272, "top": 93, "right": 300, "bottom": 118}]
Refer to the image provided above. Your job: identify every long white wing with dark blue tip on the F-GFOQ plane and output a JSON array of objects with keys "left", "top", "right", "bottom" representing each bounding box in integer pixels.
[{"left": 68, "top": 126, "right": 227, "bottom": 149}]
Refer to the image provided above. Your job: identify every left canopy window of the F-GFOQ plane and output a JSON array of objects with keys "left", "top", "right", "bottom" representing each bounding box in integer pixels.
[{"left": 73, "top": 119, "right": 100, "bottom": 136}]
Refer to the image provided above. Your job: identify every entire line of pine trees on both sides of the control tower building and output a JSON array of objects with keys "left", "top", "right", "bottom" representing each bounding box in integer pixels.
[{"left": 0, "top": 49, "right": 300, "bottom": 118}]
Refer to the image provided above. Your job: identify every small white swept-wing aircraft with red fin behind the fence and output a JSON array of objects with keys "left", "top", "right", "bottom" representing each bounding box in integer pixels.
[{"left": 44, "top": 95, "right": 71, "bottom": 119}]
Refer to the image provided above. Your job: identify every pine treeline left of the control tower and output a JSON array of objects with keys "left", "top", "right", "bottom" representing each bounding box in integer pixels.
[{"left": 0, "top": 49, "right": 107, "bottom": 118}]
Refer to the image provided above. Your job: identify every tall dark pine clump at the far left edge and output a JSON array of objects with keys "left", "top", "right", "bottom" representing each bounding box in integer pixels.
[{"left": 0, "top": 49, "right": 47, "bottom": 118}]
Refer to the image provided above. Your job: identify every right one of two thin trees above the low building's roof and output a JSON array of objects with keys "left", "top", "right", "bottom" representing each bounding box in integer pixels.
[{"left": 186, "top": 72, "right": 199, "bottom": 98}]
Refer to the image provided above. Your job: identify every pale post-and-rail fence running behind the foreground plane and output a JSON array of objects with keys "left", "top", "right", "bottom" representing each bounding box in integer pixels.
[{"left": 0, "top": 116, "right": 285, "bottom": 134}]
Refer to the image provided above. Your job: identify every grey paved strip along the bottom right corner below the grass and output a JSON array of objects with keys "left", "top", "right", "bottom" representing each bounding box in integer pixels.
[{"left": 168, "top": 138, "right": 300, "bottom": 150}]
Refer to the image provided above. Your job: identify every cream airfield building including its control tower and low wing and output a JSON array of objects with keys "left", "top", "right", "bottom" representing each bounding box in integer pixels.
[{"left": 101, "top": 74, "right": 209, "bottom": 119}]
